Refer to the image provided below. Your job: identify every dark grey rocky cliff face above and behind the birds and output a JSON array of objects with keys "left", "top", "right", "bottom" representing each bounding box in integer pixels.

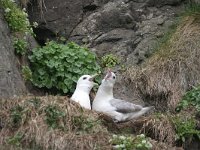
[{"left": 28, "top": 0, "right": 184, "bottom": 99}]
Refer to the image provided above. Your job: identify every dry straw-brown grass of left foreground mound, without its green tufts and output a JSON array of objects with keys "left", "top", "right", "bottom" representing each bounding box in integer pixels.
[{"left": 0, "top": 96, "right": 110, "bottom": 150}]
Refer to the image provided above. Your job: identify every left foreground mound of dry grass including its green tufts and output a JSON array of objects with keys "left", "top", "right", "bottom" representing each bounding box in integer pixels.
[{"left": 0, "top": 96, "right": 111, "bottom": 149}]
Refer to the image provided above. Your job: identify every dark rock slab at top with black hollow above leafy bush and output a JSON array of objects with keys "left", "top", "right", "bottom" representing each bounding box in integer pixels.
[{"left": 28, "top": 0, "right": 111, "bottom": 44}]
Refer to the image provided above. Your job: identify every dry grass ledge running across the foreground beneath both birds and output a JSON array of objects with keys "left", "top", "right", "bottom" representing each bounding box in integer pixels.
[{"left": 0, "top": 96, "right": 186, "bottom": 150}]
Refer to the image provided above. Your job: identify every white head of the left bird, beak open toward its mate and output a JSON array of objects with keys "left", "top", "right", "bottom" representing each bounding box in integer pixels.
[{"left": 76, "top": 74, "right": 97, "bottom": 93}]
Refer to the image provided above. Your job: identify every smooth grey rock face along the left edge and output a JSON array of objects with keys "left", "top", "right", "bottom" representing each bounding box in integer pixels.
[{"left": 0, "top": 10, "right": 27, "bottom": 98}]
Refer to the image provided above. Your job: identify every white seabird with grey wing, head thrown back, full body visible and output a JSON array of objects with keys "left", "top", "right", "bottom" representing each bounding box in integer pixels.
[{"left": 92, "top": 71, "right": 154, "bottom": 122}]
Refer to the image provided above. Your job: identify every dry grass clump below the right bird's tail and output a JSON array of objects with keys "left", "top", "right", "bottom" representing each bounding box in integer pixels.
[{"left": 113, "top": 114, "right": 176, "bottom": 147}]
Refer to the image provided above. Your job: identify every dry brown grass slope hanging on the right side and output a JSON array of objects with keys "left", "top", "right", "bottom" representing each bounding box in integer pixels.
[{"left": 125, "top": 16, "right": 200, "bottom": 110}]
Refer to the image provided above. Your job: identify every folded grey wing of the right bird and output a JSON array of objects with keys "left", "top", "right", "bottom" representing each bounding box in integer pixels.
[{"left": 110, "top": 99, "right": 142, "bottom": 113}]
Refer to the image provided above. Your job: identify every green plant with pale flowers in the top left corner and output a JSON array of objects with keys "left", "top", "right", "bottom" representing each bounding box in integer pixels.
[{"left": 0, "top": 0, "right": 33, "bottom": 33}]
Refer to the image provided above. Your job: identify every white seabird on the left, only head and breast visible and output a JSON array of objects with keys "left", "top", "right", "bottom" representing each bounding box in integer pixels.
[{"left": 70, "top": 75, "right": 96, "bottom": 110}]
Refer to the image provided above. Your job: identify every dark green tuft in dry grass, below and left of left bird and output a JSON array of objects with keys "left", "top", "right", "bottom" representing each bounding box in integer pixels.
[{"left": 45, "top": 105, "right": 65, "bottom": 129}]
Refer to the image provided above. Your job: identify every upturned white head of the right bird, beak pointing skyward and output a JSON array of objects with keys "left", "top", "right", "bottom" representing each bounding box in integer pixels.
[{"left": 101, "top": 70, "right": 116, "bottom": 87}]
